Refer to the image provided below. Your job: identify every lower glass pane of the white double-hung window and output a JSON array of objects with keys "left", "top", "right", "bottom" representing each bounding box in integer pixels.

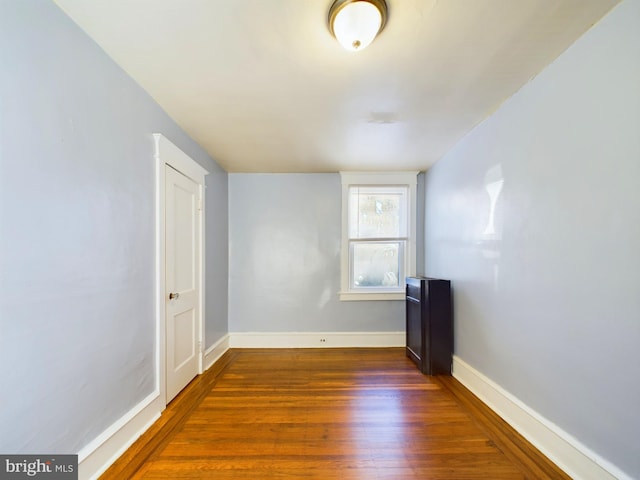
[{"left": 351, "top": 242, "right": 405, "bottom": 288}]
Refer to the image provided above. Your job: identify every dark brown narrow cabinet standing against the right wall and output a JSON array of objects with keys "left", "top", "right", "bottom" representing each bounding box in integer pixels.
[{"left": 406, "top": 277, "right": 453, "bottom": 375}]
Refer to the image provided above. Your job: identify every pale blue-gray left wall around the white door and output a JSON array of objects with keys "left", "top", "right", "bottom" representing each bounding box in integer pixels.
[{"left": 0, "top": 0, "right": 227, "bottom": 453}]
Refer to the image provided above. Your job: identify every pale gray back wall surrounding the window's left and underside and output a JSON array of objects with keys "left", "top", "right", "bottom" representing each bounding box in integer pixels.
[{"left": 229, "top": 173, "right": 404, "bottom": 332}]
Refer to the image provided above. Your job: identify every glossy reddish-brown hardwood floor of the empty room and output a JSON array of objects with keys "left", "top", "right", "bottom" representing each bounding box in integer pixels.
[{"left": 101, "top": 349, "right": 569, "bottom": 480}]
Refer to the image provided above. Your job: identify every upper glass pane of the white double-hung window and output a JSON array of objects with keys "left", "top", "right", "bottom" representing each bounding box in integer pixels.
[{"left": 349, "top": 187, "right": 407, "bottom": 238}]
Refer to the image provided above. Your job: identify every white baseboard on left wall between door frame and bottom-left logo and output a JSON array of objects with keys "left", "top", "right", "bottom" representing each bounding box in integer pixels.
[{"left": 78, "top": 391, "right": 165, "bottom": 480}]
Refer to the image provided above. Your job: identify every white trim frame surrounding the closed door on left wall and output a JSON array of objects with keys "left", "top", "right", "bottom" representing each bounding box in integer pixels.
[{"left": 153, "top": 133, "right": 209, "bottom": 406}]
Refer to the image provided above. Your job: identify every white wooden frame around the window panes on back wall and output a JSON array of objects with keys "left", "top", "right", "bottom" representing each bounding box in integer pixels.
[{"left": 339, "top": 172, "right": 419, "bottom": 301}]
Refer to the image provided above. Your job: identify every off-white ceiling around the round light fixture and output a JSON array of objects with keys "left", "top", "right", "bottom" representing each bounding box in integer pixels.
[{"left": 55, "top": 0, "right": 619, "bottom": 172}]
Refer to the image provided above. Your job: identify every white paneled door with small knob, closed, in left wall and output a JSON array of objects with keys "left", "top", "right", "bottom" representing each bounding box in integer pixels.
[{"left": 165, "top": 165, "right": 200, "bottom": 403}]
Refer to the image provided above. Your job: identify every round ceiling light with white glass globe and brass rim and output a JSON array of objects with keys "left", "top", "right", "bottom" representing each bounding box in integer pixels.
[{"left": 329, "top": 0, "right": 387, "bottom": 51}]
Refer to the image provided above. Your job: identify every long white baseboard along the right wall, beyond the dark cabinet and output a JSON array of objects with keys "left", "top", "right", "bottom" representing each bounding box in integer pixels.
[{"left": 453, "top": 355, "right": 632, "bottom": 480}]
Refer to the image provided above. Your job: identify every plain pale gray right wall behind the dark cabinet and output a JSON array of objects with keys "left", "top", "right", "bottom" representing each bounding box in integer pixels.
[{"left": 425, "top": 0, "right": 640, "bottom": 478}]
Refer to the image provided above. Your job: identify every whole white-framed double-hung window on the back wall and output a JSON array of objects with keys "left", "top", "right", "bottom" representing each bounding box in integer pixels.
[{"left": 340, "top": 172, "right": 417, "bottom": 300}]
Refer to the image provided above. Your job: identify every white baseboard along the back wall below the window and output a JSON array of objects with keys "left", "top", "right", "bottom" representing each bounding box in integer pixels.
[{"left": 229, "top": 331, "right": 406, "bottom": 348}]
